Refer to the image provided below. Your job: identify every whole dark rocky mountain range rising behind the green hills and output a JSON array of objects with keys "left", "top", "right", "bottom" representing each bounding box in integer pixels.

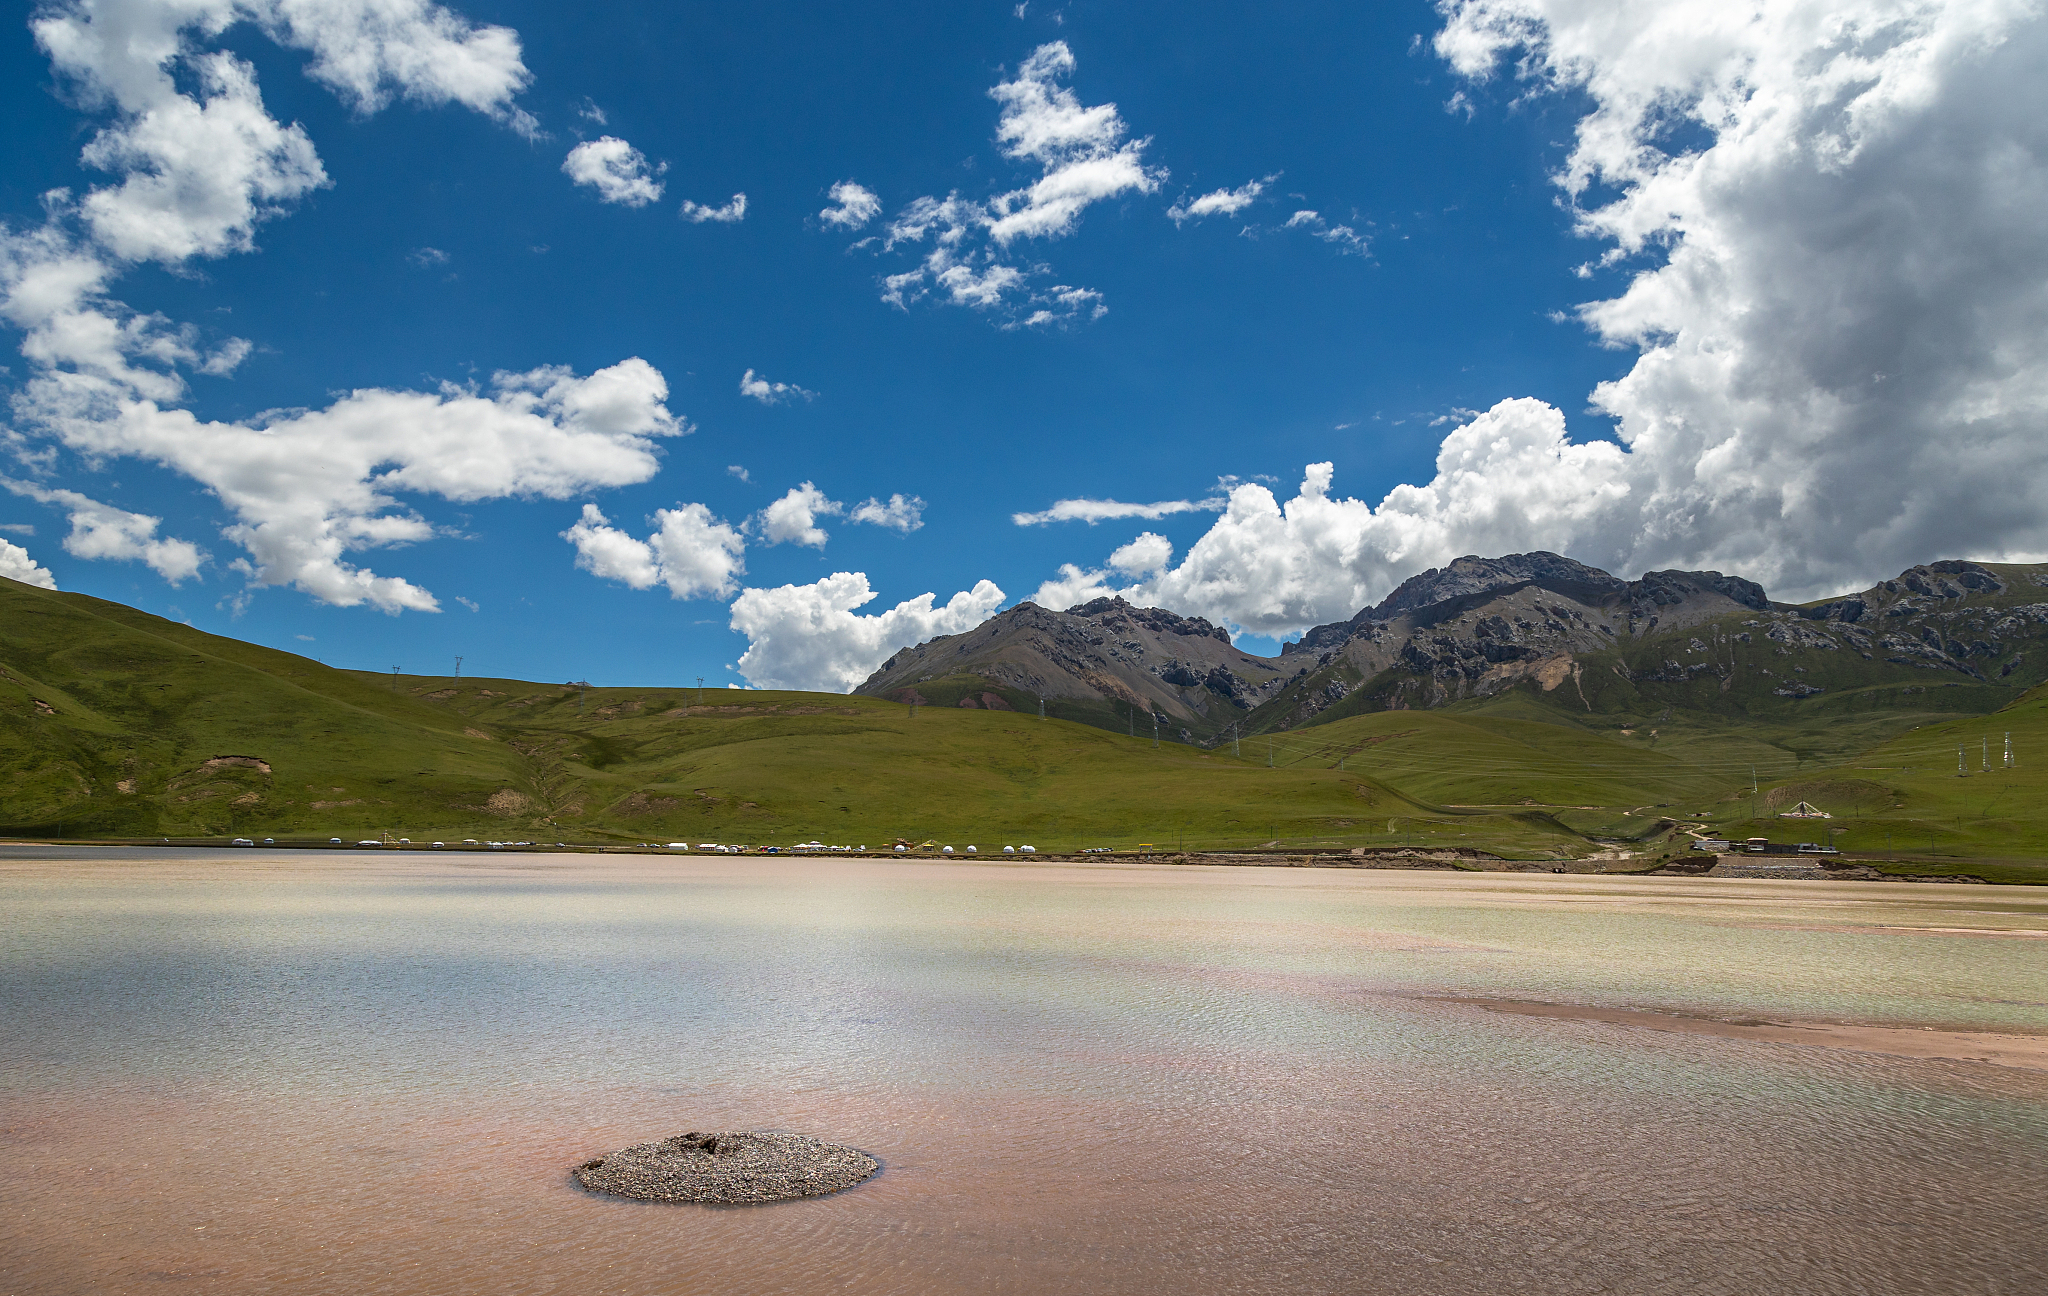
[{"left": 856, "top": 553, "right": 2048, "bottom": 745}]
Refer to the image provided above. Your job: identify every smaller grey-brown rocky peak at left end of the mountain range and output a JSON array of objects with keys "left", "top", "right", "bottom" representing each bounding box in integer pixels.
[{"left": 854, "top": 598, "right": 1282, "bottom": 735}]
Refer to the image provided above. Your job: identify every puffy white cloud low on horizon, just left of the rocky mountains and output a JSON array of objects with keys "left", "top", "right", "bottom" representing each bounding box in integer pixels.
[{"left": 731, "top": 571, "right": 1004, "bottom": 692}]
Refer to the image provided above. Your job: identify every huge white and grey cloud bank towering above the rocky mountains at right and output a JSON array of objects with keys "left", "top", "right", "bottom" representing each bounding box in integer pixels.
[{"left": 1063, "top": 0, "right": 2048, "bottom": 633}]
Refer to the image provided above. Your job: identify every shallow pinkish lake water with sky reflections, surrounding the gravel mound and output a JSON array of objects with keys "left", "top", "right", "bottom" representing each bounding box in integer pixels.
[{"left": 0, "top": 852, "right": 2048, "bottom": 1294}]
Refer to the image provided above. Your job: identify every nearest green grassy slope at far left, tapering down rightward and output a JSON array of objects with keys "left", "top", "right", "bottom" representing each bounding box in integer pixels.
[{"left": 0, "top": 581, "right": 528, "bottom": 835}]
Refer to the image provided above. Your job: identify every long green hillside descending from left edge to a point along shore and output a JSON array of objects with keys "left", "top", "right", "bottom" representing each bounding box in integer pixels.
[{"left": 0, "top": 581, "right": 1575, "bottom": 852}]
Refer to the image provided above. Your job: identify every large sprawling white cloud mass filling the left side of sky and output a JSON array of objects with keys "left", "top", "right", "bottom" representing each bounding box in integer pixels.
[{"left": 0, "top": 0, "right": 577, "bottom": 610}]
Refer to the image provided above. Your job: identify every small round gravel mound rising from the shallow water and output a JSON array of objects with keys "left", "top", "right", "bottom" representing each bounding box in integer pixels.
[{"left": 575, "top": 1132, "right": 883, "bottom": 1206}]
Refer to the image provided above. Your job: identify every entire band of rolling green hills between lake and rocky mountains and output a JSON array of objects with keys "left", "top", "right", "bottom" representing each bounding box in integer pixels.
[{"left": 0, "top": 581, "right": 2048, "bottom": 880}]
